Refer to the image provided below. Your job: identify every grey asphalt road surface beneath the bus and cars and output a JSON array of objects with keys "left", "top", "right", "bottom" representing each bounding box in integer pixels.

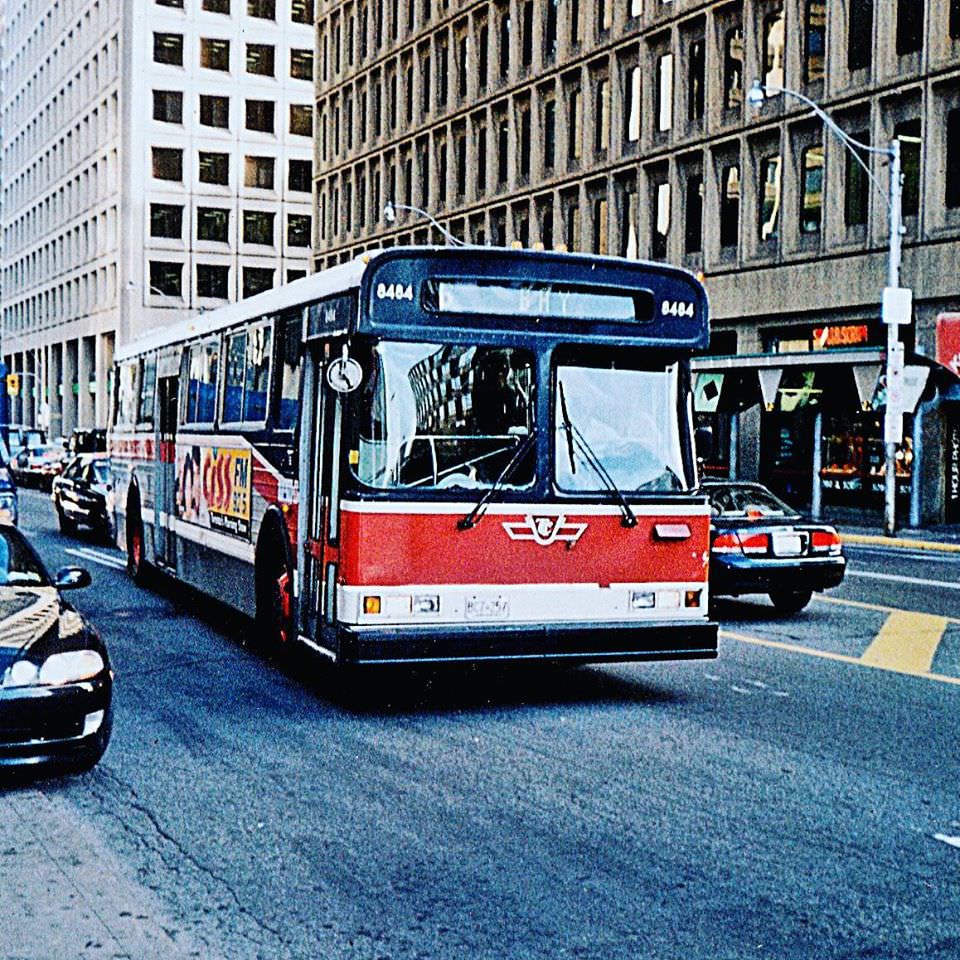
[{"left": 0, "top": 495, "right": 960, "bottom": 960}]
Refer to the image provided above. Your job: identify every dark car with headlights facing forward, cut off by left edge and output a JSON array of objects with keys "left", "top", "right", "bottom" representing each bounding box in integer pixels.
[{"left": 0, "top": 524, "right": 113, "bottom": 770}]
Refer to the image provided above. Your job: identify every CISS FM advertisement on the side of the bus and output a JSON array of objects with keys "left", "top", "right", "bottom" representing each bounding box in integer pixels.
[{"left": 177, "top": 445, "right": 250, "bottom": 537}]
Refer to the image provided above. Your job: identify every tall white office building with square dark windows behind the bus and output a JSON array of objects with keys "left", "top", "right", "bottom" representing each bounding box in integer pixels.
[{"left": 0, "top": 0, "right": 313, "bottom": 435}]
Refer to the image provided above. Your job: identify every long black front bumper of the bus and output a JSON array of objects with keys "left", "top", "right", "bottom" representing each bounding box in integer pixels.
[{"left": 338, "top": 619, "right": 717, "bottom": 664}]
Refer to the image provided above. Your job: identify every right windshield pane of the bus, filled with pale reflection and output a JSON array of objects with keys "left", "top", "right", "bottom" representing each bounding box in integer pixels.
[{"left": 554, "top": 364, "right": 689, "bottom": 492}]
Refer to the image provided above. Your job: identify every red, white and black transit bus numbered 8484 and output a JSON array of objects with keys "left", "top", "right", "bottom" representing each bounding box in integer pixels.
[{"left": 109, "top": 247, "right": 717, "bottom": 664}]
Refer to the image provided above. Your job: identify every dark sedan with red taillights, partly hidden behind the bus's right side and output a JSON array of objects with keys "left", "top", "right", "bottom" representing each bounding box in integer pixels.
[{"left": 703, "top": 480, "right": 846, "bottom": 614}]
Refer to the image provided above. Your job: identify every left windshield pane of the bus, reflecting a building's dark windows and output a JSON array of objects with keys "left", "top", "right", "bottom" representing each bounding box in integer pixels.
[{"left": 350, "top": 341, "right": 535, "bottom": 490}]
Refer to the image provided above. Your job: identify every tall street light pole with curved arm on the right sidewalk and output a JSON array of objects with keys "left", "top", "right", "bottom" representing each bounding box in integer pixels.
[{"left": 747, "top": 80, "right": 913, "bottom": 536}]
